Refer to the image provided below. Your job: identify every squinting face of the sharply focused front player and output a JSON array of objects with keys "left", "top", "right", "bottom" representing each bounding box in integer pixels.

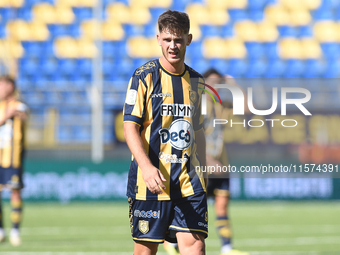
[{"left": 157, "top": 30, "right": 192, "bottom": 66}]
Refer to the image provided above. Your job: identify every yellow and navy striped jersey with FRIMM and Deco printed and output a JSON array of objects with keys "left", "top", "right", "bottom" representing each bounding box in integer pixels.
[{"left": 124, "top": 60, "right": 205, "bottom": 200}]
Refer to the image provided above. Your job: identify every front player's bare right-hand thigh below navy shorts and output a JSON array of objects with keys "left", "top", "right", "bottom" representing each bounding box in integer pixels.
[{"left": 176, "top": 232, "right": 205, "bottom": 255}]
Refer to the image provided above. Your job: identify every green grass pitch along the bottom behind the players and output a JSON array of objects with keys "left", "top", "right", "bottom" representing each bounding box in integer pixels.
[{"left": 0, "top": 201, "right": 340, "bottom": 255}]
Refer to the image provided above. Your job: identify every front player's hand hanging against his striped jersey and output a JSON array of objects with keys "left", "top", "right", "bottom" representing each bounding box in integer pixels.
[{"left": 142, "top": 166, "right": 166, "bottom": 194}]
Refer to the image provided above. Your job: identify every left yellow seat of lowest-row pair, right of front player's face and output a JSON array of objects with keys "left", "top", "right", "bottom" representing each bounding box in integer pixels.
[{"left": 203, "top": 37, "right": 228, "bottom": 58}]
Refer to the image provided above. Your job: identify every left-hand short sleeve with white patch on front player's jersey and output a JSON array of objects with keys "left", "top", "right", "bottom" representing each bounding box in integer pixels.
[{"left": 124, "top": 76, "right": 146, "bottom": 126}]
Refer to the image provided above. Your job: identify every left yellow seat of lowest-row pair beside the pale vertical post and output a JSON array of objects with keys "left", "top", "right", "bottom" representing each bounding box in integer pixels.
[{"left": 54, "top": 36, "right": 79, "bottom": 58}]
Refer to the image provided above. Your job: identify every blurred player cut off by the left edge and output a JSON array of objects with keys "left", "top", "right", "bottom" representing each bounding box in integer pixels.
[{"left": 0, "top": 76, "right": 28, "bottom": 246}]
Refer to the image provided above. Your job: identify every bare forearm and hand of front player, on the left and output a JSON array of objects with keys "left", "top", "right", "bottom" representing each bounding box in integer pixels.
[{"left": 124, "top": 122, "right": 166, "bottom": 194}]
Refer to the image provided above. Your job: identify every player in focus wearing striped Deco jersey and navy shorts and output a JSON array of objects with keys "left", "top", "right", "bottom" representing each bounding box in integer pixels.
[{"left": 124, "top": 10, "right": 208, "bottom": 255}]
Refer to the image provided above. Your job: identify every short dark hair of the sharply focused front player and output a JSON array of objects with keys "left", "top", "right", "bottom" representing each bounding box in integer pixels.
[{"left": 158, "top": 10, "right": 190, "bottom": 35}]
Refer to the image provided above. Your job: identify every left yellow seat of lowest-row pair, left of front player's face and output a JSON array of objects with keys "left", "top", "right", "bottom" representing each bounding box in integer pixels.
[{"left": 128, "top": 36, "right": 152, "bottom": 58}]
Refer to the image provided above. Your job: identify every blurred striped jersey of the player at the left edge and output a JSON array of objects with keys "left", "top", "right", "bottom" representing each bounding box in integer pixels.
[{"left": 0, "top": 101, "right": 26, "bottom": 168}]
